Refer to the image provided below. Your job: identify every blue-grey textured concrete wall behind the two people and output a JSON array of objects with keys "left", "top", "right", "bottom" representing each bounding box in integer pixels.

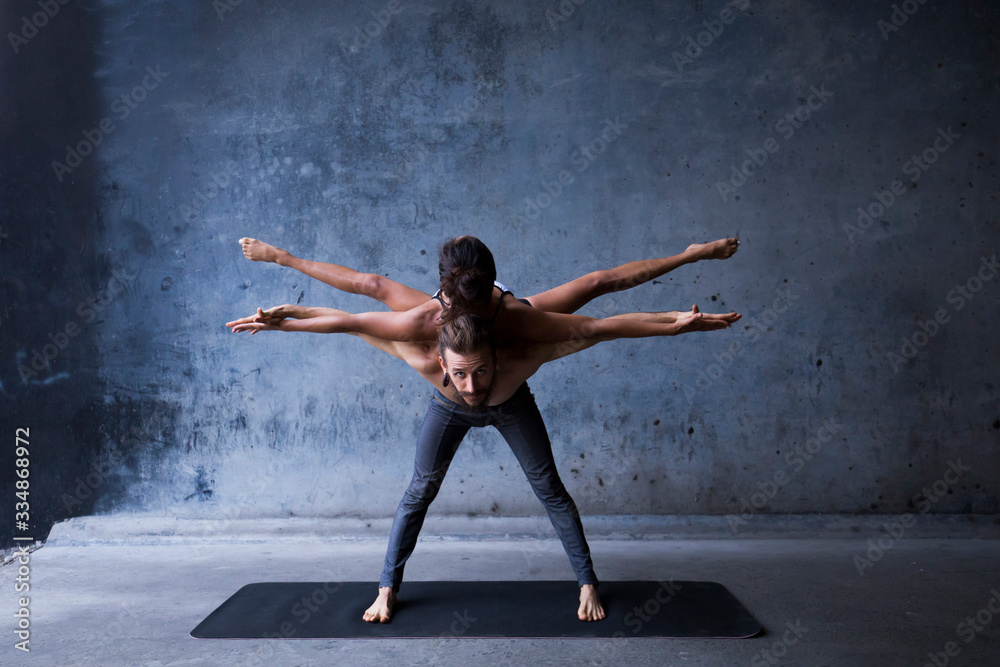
[{"left": 0, "top": 0, "right": 1000, "bottom": 544}]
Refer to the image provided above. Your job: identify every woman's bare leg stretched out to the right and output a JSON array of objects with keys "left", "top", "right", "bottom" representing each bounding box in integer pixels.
[{"left": 528, "top": 239, "right": 739, "bottom": 313}]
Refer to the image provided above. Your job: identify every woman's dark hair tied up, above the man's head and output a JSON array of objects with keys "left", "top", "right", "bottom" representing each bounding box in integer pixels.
[{"left": 438, "top": 236, "right": 497, "bottom": 323}]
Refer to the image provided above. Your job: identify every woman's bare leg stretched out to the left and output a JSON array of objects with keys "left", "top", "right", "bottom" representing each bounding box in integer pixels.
[{"left": 240, "top": 238, "right": 431, "bottom": 312}]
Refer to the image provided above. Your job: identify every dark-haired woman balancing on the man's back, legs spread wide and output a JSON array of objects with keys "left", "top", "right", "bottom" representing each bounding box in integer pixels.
[{"left": 232, "top": 236, "right": 739, "bottom": 345}]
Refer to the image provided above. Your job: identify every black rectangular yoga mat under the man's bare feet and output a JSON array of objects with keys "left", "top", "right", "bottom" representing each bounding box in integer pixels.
[{"left": 191, "top": 581, "right": 761, "bottom": 639}]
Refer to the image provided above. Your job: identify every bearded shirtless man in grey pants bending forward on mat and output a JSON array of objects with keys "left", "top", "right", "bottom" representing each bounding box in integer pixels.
[{"left": 227, "top": 305, "right": 741, "bottom": 623}]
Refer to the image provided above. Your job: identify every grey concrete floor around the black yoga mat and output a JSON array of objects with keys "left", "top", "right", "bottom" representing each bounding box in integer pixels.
[{"left": 0, "top": 515, "right": 1000, "bottom": 667}]
